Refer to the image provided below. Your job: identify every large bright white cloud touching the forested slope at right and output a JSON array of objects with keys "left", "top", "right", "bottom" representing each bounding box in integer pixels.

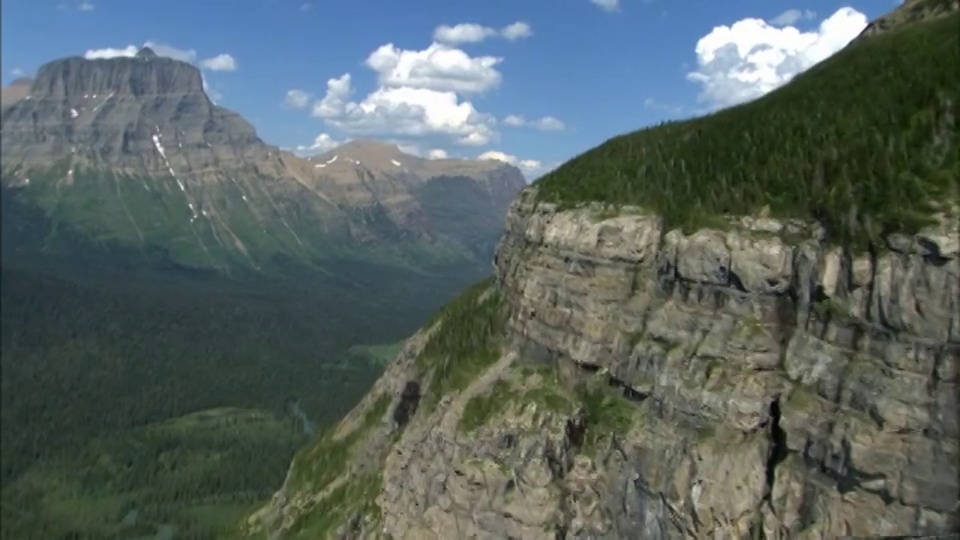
[{"left": 687, "top": 7, "right": 867, "bottom": 108}]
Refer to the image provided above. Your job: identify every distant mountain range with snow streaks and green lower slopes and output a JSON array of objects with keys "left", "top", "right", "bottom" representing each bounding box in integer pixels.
[{"left": 0, "top": 48, "right": 526, "bottom": 272}]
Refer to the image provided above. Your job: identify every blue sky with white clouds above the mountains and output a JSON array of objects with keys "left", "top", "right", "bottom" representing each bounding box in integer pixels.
[{"left": 0, "top": 0, "right": 896, "bottom": 177}]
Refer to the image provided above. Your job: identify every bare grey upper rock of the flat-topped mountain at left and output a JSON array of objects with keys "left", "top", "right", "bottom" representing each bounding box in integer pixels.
[{"left": 3, "top": 49, "right": 266, "bottom": 173}]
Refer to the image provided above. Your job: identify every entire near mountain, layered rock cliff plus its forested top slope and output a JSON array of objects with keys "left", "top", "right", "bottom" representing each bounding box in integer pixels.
[{"left": 242, "top": 0, "right": 960, "bottom": 540}]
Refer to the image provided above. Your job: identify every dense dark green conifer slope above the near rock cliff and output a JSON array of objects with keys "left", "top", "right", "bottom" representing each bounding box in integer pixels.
[{"left": 536, "top": 8, "right": 960, "bottom": 247}]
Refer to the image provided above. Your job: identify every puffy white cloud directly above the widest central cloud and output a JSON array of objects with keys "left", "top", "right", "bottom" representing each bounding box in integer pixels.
[{"left": 365, "top": 43, "right": 503, "bottom": 93}]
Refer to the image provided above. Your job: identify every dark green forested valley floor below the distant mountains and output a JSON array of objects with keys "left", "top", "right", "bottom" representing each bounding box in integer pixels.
[{"left": 0, "top": 189, "right": 480, "bottom": 539}]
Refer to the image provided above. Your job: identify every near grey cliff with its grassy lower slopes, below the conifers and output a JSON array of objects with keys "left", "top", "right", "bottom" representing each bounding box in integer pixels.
[{"left": 248, "top": 190, "right": 960, "bottom": 539}]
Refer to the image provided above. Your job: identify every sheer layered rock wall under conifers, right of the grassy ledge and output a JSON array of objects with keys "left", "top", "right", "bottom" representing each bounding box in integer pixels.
[{"left": 497, "top": 194, "right": 960, "bottom": 538}]
